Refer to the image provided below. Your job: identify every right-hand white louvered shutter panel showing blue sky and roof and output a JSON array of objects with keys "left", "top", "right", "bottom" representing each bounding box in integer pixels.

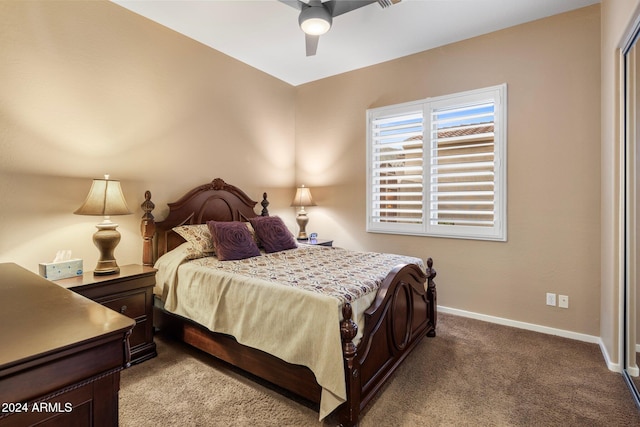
[{"left": 429, "top": 101, "right": 496, "bottom": 227}]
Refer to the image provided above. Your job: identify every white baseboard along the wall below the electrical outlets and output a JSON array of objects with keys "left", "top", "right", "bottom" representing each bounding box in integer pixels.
[{"left": 438, "top": 305, "right": 622, "bottom": 372}]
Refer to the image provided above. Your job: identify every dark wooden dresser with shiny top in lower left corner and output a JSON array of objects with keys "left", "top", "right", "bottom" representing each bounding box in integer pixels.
[{"left": 0, "top": 263, "right": 135, "bottom": 427}]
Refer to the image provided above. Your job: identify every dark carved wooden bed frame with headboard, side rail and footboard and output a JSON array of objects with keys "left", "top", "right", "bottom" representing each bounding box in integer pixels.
[{"left": 141, "top": 178, "right": 437, "bottom": 426}]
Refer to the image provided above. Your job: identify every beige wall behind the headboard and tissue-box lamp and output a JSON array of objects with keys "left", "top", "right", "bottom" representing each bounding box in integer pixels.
[{"left": 0, "top": 1, "right": 295, "bottom": 271}]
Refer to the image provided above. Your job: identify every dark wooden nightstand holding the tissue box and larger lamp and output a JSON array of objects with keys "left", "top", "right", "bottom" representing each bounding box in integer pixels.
[{"left": 53, "top": 264, "right": 158, "bottom": 364}]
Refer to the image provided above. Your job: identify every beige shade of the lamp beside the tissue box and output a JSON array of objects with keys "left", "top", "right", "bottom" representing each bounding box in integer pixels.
[{"left": 74, "top": 175, "right": 131, "bottom": 216}]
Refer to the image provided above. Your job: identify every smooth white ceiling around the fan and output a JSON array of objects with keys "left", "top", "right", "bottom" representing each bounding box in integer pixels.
[{"left": 112, "top": 0, "right": 600, "bottom": 86}]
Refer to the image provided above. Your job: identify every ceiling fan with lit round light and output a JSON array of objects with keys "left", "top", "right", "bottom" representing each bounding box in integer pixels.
[{"left": 279, "top": 0, "right": 402, "bottom": 56}]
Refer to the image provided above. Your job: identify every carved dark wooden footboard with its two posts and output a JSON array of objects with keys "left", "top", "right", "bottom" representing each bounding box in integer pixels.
[{"left": 340, "top": 258, "right": 437, "bottom": 426}]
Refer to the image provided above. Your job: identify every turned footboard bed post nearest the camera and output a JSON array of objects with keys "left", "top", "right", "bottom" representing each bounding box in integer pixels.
[{"left": 339, "top": 302, "right": 362, "bottom": 427}]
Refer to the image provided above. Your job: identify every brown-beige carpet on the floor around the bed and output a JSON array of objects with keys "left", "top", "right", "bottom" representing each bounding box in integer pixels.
[{"left": 120, "top": 315, "right": 640, "bottom": 427}]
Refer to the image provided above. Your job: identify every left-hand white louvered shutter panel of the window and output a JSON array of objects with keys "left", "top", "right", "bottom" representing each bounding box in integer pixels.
[{"left": 370, "top": 112, "right": 424, "bottom": 226}]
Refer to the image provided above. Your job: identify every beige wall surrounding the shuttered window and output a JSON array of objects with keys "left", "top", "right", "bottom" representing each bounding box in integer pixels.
[{"left": 296, "top": 5, "right": 600, "bottom": 336}]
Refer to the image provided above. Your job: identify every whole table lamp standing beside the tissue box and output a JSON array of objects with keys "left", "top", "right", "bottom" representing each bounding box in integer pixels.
[{"left": 74, "top": 175, "right": 131, "bottom": 276}]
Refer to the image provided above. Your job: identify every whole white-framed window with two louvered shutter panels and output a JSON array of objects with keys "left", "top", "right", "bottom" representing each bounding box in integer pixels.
[{"left": 367, "top": 84, "right": 507, "bottom": 241}]
